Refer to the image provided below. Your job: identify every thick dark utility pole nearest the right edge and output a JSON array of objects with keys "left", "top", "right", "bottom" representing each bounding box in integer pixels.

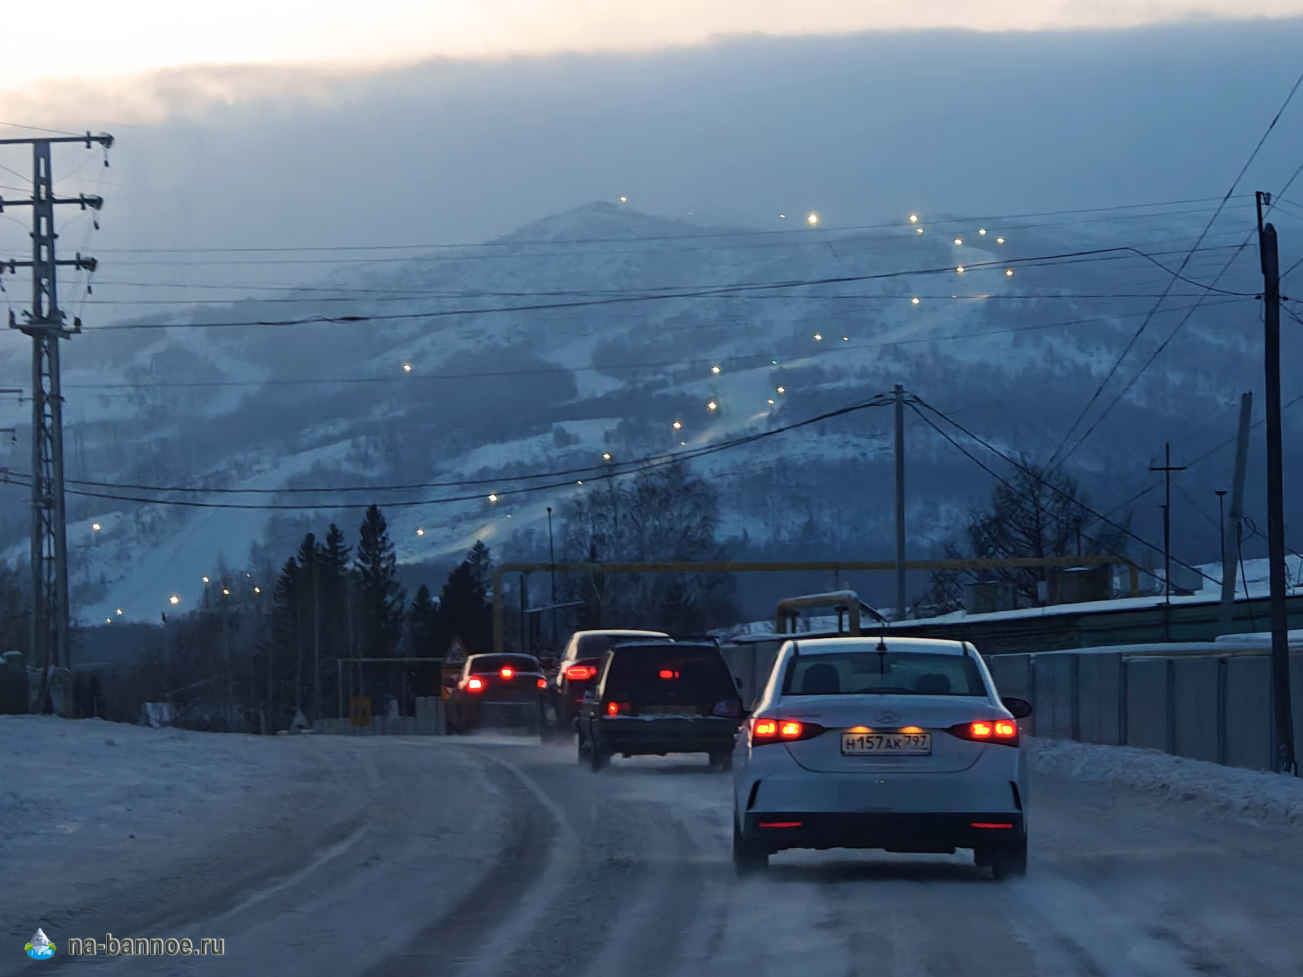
[{"left": 1257, "top": 190, "right": 1296, "bottom": 774}]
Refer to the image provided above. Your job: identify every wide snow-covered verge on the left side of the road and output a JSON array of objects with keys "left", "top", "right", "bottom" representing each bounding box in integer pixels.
[{"left": 0, "top": 715, "right": 515, "bottom": 974}]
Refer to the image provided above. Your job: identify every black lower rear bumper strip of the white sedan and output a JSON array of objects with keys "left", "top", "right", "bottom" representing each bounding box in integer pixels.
[{"left": 744, "top": 812, "right": 1027, "bottom": 852}]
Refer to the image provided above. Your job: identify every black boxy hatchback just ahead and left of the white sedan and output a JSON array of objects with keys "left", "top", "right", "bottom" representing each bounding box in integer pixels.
[{"left": 577, "top": 642, "right": 744, "bottom": 770}]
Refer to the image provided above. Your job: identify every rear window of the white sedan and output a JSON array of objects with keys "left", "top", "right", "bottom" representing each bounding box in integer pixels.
[{"left": 783, "top": 651, "right": 986, "bottom": 696}]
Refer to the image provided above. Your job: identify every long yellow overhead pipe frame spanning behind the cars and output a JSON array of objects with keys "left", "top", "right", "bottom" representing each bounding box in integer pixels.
[{"left": 493, "top": 556, "right": 1139, "bottom": 654}]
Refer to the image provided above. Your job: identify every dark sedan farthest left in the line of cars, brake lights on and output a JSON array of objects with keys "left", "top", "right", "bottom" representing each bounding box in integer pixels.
[{"left": 444, "top": 654, "right": 547, "bottom": 733}]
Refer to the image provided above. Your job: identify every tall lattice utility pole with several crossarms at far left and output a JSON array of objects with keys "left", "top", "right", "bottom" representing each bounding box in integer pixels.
[{"left": 0, "top": 132, "right": 113, "bottom": 710}]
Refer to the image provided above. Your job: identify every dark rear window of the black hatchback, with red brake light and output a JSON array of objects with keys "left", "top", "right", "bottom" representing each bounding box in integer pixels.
[{"left": 606, "top": 645, "right": 737, "bottom": 705}]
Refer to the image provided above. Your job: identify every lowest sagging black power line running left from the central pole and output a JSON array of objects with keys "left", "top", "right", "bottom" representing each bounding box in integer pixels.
[{"left": 4, "top": 397, "right": 885, "bottom": 511}]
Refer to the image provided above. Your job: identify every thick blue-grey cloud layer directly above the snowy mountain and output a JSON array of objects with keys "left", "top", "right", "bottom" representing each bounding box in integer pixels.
[{"left": 0, "top": 13, "right": 1303, "bottom": 293}]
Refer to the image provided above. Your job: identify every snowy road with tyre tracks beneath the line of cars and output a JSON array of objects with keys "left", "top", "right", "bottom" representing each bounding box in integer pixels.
[{"left": 0, "top": 737, "right": 1303, "bottom": 977}]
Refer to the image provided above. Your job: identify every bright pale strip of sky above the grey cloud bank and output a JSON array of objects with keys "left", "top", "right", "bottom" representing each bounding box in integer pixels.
[{"left": 0, "top": 0, "right": 1303, "bottom": 89}]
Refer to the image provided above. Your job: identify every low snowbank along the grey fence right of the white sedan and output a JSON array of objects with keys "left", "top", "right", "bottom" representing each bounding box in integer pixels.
[{"left": 1024, "top": 736, "right": 1303, "bottom": 825}]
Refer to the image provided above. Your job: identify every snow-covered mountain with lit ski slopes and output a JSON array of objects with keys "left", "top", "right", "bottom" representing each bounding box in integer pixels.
[{"left": 0, "top": 203, "right": 1293, "bottom": 623}]
